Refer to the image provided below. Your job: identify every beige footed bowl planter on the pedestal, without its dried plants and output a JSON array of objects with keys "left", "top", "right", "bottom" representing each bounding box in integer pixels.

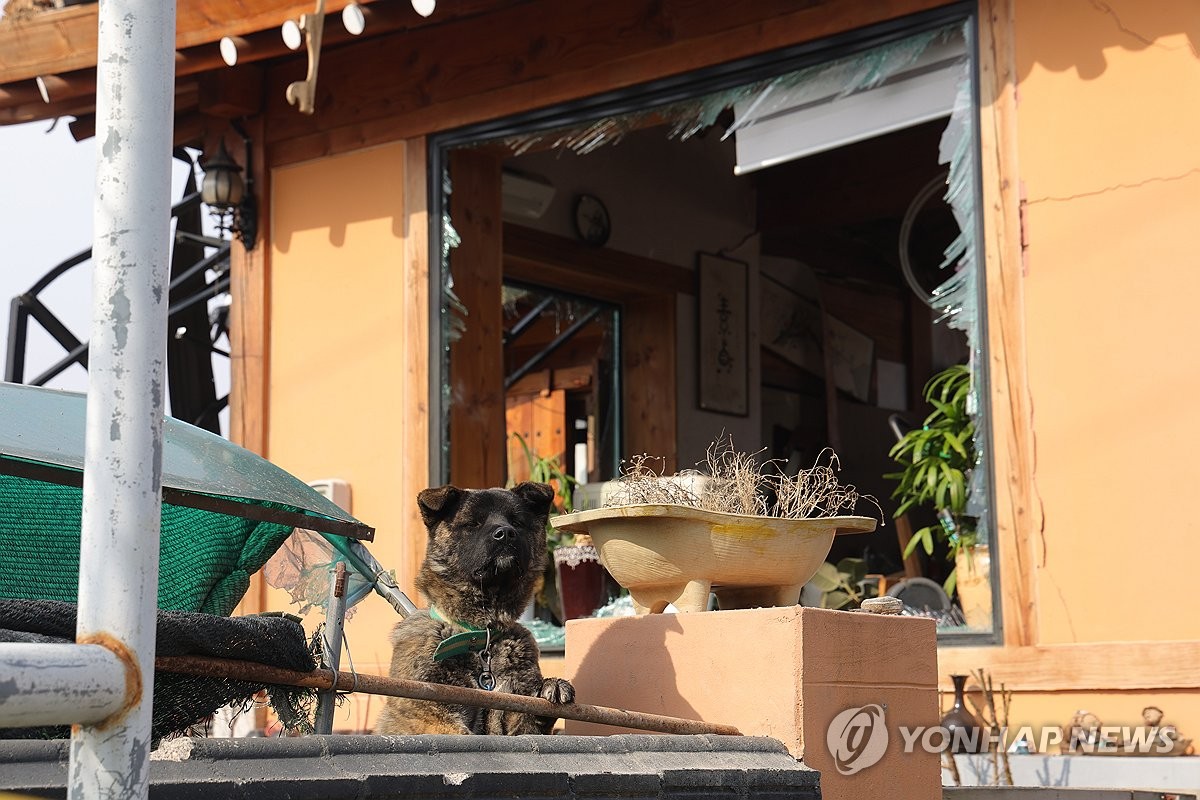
[{"left": 551, "top": 505, "right": 875, "bottom": 614}]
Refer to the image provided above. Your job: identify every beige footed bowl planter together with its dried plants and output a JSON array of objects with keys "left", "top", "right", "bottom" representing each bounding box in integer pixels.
[{"left": 553, "top": 435, "right": 882, "bottom": 613}]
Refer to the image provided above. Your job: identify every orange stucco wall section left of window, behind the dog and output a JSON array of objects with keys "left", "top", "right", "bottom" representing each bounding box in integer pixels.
[{"left": 268, "top": 144, "right": 424, "bottom": 728}]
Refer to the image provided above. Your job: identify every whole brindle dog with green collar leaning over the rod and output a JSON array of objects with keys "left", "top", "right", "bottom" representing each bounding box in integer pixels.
[{"left": 376, "top": 482, "right": 575, "bottom": 735}]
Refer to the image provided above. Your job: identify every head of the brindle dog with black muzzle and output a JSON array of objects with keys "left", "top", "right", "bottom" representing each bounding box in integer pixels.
[{"left": 416, "top": 482, "right": 554, "bottom": 620}]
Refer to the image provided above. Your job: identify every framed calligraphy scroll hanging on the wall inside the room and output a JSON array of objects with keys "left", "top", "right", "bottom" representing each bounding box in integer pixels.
[{"left": 696, "top": 253, "right": 750, "bottom": 416}]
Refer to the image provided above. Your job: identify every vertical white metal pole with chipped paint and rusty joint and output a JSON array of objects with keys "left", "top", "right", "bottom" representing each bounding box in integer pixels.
[{"left": 67, "top": 0, "right": 175, "bottom": 800}]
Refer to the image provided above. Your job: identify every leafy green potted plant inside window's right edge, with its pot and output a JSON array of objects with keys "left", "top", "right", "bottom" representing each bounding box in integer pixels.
[{"left": 886, "top": 365, "right": 991, "bottom": 627}]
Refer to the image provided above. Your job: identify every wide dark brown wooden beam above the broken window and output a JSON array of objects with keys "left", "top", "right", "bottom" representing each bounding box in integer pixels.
[{"left": 268, "top": 0, "right": 943, "bottom": 163}]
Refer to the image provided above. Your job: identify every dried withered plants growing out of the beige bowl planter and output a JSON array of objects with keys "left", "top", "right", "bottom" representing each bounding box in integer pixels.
[{"left": 604, "top": 435, "right": 883, "bottom": 521}]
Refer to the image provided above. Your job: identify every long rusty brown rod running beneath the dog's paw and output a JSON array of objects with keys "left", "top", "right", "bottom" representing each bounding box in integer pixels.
[{"left": 155, "top": 656, "right": 742, "bottom": 736}]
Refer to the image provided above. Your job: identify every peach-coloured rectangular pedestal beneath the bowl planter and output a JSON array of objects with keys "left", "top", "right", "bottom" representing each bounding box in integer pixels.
[{"left": 564, "top": 606, "right": 942, "bottom": 800}]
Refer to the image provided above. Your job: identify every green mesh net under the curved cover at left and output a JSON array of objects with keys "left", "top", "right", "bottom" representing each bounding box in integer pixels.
[{"left": 0, "top": 475, "right": 296, "bottom": 615}]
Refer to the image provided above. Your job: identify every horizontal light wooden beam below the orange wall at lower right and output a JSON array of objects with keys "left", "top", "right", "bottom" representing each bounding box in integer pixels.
[{"left": 937, "top": 640, "right": 1200, "bottom": 692}]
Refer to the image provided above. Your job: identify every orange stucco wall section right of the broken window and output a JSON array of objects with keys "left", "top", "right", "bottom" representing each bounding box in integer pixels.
[{"left": 1015, "top": 0, "right": 1200, "bottom": 642}]
